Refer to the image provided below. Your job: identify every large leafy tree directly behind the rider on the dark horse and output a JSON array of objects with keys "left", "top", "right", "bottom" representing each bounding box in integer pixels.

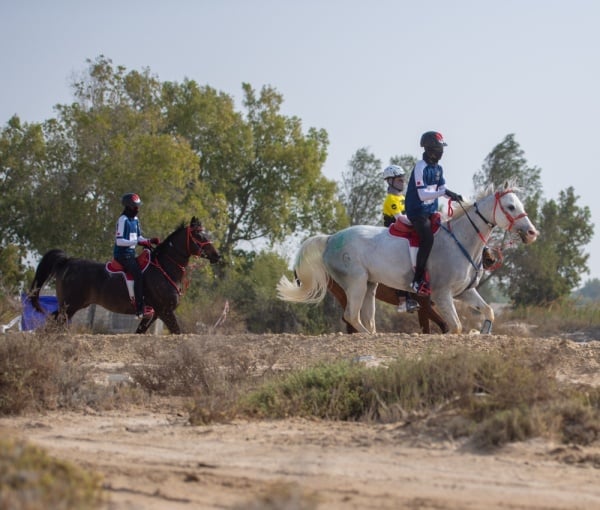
[{"left": 3, "top": 56, "right": 213, "bottom": 259}]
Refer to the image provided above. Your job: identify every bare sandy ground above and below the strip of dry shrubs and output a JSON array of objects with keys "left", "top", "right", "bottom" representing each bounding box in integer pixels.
[{"left": 0, "top": 334, "right": 600, "bottom": 510}]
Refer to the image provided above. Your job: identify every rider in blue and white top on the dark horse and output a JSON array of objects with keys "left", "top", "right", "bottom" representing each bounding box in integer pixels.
[{"left": 113, "top": 193, "right": 160, "bottom": 319}]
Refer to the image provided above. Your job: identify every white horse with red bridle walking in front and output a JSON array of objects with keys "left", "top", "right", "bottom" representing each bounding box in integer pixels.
[{"left": 277, "top": 185, "right": 538, "bottom": 333}]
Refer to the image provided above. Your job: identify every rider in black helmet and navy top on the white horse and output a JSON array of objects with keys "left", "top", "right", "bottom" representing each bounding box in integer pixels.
[{"left": 406, "top": 131, "right": 463, "bottom": 295}]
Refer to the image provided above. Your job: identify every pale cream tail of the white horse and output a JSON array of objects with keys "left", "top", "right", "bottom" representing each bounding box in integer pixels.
[{"left": 277, "top": 234, "right": 329, "bottom": 303}]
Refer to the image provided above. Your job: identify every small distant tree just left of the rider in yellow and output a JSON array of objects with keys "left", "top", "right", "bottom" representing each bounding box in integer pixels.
[{"left": 340, "top": 147, "right": 385, "bottom": 225}]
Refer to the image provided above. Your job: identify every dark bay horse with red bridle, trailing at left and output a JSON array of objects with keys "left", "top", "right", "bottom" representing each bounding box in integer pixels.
[{"left": 29, "top": 217, "right": 220, "bottom": 334}]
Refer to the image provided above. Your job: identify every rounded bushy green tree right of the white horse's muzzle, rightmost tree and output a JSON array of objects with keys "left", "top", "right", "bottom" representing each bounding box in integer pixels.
[{"left": 507, "top": 187, "right": 594, "bottom": 306}]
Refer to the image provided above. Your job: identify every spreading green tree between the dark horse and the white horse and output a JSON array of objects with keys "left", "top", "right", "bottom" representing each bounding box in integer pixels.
[{"left": 164, "top": 81, "right": 343, "bottom": 255}]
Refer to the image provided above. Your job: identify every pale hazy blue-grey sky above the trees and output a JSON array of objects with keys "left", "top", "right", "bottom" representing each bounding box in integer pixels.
[{"left": 0, "top": 0, "right": 600, "bottom": 283}]
